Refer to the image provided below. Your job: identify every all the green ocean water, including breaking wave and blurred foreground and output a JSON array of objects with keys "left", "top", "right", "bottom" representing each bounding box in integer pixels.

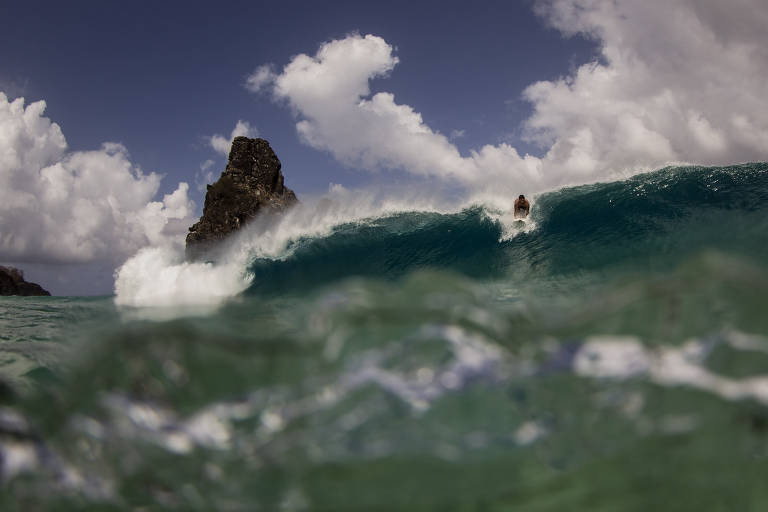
[{"left": 0, "top": 164, "right": 768, "bottom": 511}]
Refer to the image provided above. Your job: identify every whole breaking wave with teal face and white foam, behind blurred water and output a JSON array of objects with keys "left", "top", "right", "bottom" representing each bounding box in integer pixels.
[{"left": 116, "top": 163, "right": 768, "bottom": 305}]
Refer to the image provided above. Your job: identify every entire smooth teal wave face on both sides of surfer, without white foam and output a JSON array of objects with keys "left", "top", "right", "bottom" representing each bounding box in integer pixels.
[{"left": 249, "top": 164, "right": 768, "bottom": 293}]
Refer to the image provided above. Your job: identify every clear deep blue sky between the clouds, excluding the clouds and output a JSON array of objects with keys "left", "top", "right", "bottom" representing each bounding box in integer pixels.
[{"left": 0, "top": 1, "right": 596, "bottom": 200}]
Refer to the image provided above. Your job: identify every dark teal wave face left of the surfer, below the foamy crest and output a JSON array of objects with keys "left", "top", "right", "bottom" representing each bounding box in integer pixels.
[{"left": 249, "top": 207, "right": 504, "bottom": 292}]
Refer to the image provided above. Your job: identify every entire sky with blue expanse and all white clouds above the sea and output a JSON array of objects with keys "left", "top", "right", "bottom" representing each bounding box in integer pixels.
[{"left": 0, "top": 0, "right": 768, "bottom": 294}]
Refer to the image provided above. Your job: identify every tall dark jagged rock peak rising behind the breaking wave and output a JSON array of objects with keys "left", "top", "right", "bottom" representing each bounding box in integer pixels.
[{"left": 187, "top": 137, "right": 297, "bottom": 259}]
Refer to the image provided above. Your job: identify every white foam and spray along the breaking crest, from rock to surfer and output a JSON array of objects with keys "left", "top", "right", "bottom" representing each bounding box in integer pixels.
[{"left": 115, "top": 185, "right": 535, "bottom": 308}]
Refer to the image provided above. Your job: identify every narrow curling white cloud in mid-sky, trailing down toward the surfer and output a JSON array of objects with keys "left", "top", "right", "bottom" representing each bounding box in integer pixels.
[{"left": 248, "top": 34, "right": 560, "bottom": 194}]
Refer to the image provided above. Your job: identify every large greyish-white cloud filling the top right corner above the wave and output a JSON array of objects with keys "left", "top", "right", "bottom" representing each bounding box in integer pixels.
[{"left": 524, "top": 0, "right": 768, "bottom": 175}]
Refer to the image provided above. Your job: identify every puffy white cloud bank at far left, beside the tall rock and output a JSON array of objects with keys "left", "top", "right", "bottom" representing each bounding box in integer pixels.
[{"left": 0, "top": 92, "right": 194, "bottom": 263}]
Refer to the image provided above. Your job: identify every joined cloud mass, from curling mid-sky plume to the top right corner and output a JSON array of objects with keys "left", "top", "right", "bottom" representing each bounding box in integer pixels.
[{"left": 251, "top": 5, "right": 768, "bottom": 197}]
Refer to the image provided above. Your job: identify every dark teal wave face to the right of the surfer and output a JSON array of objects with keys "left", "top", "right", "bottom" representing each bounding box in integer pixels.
[{"left": 534, "top": 164, "right": 768, "bottom": 272}]
